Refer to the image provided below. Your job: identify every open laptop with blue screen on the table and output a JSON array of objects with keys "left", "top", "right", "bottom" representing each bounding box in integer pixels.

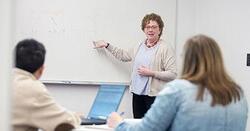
[{"left": 81, "top": 85, "right": 126, "bottom": 125}]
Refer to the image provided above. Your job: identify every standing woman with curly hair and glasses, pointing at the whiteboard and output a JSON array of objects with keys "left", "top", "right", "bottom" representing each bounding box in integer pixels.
[{"left": 94, "top": 13, "right": 176, "bottom": 118}]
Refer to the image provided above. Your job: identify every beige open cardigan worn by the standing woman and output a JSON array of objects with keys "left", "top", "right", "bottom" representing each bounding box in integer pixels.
[{"left": 107, "top": 39, "right": 177, "bottom": 96}]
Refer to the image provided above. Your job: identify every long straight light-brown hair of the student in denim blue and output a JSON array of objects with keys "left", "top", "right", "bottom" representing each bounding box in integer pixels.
[{"left": 181, "top": 34, "right": 242, "bottom": 106}]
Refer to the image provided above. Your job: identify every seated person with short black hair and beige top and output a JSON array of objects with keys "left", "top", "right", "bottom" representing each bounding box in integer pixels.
[{"left": 12, "top": 39, "right": 80, "bottom": 131}]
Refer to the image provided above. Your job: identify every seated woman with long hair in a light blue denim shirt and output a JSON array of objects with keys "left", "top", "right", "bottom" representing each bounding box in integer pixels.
[{"left": 108, "top": 35, "right": 248, "bottom": 131}]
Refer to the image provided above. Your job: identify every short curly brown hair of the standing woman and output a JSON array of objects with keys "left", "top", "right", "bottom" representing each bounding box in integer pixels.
[{"left": 141, "top": 13, "right": 164, "bottom": 37}]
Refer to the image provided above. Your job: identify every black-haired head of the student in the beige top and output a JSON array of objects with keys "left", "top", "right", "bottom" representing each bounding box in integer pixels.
[{"left": 15, "top": 39, "right": 46, "bottom": 74}]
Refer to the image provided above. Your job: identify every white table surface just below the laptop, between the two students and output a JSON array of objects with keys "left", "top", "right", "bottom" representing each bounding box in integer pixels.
[{"left": 72, "top": 125, "right": 114, "bottom": 131}]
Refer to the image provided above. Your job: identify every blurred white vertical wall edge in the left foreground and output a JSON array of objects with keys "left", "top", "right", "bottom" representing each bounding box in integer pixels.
[{"left": 0, "top": 0, "right": 12, "bottom": 131}]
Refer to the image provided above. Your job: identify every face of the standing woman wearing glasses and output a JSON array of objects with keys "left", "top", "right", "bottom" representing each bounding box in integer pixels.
[{"left": 144, "top": 20, "right": 160, "bottom": 41}]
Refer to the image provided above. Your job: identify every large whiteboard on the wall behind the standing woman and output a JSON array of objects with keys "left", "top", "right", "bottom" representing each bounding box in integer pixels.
[{"left": 14, "top": 0, "right": 176, "bottom": 83}]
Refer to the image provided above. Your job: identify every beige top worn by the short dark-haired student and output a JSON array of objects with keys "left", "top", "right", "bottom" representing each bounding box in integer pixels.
[{"left": 12, "top": 69, "right": 80, "bottom": 131}]
